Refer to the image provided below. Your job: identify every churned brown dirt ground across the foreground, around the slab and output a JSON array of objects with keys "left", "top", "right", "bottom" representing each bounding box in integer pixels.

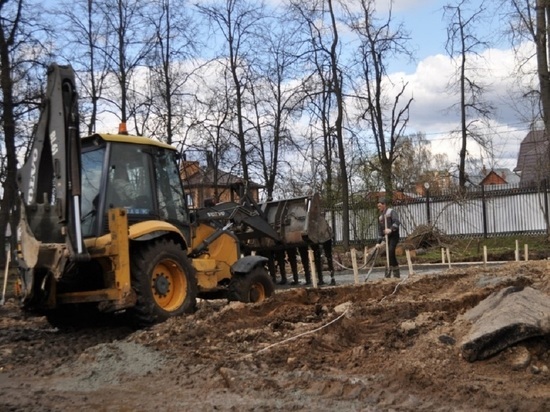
[{"left": 0, "top": 261, "right": 550, "bottom": 412}]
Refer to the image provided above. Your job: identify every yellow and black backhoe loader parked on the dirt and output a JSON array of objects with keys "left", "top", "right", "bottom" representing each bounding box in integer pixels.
[{"left": 18, "top": 64, "right": 330, "bottom": 326}]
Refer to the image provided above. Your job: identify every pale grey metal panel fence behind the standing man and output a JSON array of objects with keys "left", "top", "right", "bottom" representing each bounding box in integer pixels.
[{"left": 327, "top": 185, "right": 550, "bottom": 244}]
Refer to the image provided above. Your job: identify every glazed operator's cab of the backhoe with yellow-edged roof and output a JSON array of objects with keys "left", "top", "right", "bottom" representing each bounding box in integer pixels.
[{"left": 81, "top": 134, "right": 189, "bottom": 237}]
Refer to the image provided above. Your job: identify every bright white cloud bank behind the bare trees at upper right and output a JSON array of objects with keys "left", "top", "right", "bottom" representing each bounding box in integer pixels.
[{"left": 384, "top": 45, "right": 534, "bottom": 169}]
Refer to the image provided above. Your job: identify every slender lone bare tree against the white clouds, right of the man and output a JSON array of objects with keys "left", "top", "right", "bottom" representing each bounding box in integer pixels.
[{"left": 443, "top": 0, "right": 493, "bottom": 188}]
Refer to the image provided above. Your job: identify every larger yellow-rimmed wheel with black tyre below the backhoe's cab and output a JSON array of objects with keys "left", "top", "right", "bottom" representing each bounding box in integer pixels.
[{"left": 130, "top": 239, "right": 197, "bottom": 327}]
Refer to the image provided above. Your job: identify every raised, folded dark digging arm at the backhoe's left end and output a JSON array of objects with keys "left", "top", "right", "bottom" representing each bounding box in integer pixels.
[{"left": 18, "top": 64, "right": 89, "bottom": 267}]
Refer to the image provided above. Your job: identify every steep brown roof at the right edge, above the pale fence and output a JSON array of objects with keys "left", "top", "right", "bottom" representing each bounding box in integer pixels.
[{"left": 514, "top": 130, "right": 550, "bottom": 183}]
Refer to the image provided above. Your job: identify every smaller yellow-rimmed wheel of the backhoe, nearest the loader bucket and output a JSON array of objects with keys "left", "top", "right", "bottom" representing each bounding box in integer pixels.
[{"left": 228, "top": 266, "right": 275, "bottom": 303}]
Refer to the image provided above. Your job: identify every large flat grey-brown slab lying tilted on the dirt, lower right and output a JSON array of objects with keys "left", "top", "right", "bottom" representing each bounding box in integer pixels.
[{"left": 461, "top": 287, "right": 550, "bottom": 362}]
